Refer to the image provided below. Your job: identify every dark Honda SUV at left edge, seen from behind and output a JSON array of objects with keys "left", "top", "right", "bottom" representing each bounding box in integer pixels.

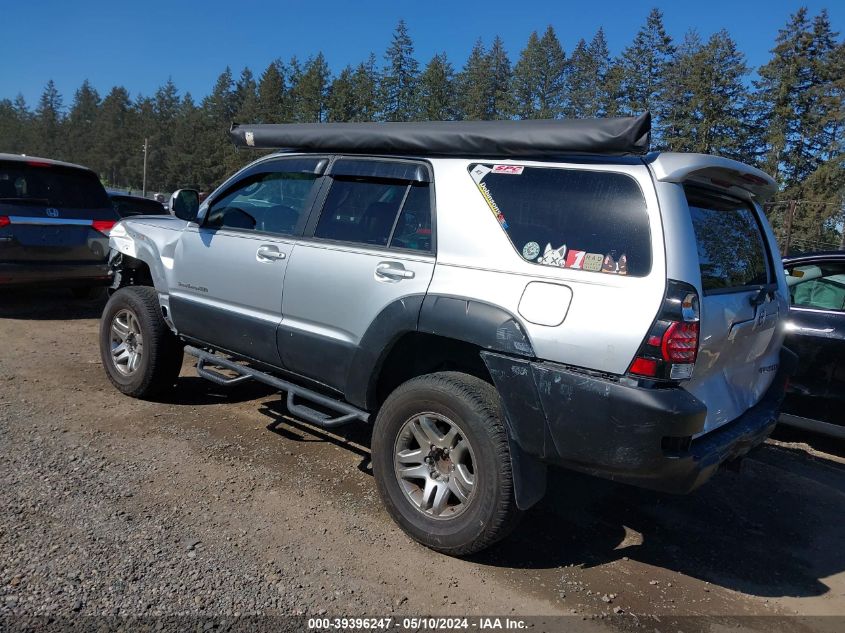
[{"left": 0, "top": 154, "right": 119, "bottom": 295}]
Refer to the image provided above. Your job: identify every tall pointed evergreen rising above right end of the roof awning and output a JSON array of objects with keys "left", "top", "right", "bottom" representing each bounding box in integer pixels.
[{"left": 621, "top": 9, "right": 675, "bottom": 130}]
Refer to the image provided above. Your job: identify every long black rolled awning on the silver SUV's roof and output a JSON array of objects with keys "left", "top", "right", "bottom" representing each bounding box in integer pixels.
[{"left": 230, "top": 112, "right": 651, "bottom": 158}]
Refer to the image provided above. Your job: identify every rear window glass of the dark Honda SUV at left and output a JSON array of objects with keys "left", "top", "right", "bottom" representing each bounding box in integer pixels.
[{"left": 0, "top": 161, "right": 111, "bottom": 209}]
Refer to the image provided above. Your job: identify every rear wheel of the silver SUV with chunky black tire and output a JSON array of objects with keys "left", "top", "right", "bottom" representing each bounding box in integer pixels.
[{"left": 372, "top": 372, "right": 520, "bottom": 555}]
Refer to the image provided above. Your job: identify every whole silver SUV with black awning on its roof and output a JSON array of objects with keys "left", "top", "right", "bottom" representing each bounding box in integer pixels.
[{"left": 100, "top": 115, "right": 794, "bottom": 555}]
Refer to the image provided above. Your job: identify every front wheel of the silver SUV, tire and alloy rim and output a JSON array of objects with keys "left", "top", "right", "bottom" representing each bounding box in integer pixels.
[{"left": 100, "top": 286, "right": 183, "bottom": 398}]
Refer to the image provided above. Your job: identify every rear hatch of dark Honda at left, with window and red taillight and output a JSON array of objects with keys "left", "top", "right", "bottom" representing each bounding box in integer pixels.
[{"left": 0, "top": 160, "right": 118, "bottom": 263}]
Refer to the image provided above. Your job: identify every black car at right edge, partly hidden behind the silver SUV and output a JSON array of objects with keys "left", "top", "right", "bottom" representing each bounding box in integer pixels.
[{"left": 780, "top": 251, "right": 845, "bottom": 439}]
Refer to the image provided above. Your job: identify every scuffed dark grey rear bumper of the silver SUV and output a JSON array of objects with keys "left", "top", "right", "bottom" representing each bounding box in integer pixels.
[{"left": 482, "top": 350, "right": 795, "bottom": 493}]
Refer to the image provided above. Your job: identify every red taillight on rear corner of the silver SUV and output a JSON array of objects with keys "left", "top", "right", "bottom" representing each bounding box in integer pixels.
[{"left": 628, "top": 279, "right": 701, "bottom": 381}]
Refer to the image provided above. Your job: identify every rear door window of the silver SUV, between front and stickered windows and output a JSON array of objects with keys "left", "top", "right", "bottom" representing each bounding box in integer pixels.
[{"left": 314, "top": 177, "right": 431, "bottom": 251}]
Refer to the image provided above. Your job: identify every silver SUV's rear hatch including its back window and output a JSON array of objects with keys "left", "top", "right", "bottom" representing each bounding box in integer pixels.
[{"left": 684, "top": 184, "right": 786, "bottom": 432}]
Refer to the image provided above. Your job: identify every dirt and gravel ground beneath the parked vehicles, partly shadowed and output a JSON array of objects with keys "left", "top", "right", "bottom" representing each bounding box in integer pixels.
[{"left": 0, "top": 291, "right": 845, "bottom": 631}]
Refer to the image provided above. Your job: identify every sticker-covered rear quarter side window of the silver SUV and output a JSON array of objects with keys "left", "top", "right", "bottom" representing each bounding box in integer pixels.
[{"left": 469, "top": 163, "right": 651, "bottom": 277}]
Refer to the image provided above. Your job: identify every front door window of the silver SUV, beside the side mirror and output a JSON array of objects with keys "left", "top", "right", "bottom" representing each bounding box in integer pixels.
[{"left": 203, "top": 160, "right": 318, "bottom": 235}]
